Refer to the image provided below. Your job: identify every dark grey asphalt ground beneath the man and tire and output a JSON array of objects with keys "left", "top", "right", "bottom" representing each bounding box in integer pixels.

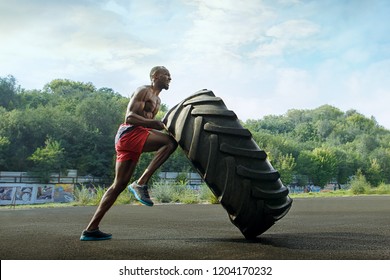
[{"left": 0, "top": 195, "right": 390, "bottom": 260}]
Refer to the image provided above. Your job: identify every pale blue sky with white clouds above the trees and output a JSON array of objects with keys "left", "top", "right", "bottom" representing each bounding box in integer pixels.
[{"left": 0, "top": 0, "right": 390, "bottom": 129}]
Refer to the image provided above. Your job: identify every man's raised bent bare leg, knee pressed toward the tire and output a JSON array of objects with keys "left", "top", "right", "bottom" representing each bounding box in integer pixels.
[{"left": 138, "top": 130, "right": 177, "bottom": 185}]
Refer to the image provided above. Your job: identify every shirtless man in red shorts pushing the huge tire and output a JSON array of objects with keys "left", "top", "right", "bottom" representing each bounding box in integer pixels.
[{"left": 80, "top": 66, "right": 177, "bottom": 241}]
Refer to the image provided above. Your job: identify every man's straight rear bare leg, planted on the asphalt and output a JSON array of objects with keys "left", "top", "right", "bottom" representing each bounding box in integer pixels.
[{"left": 86, "top": 160, "right": 137, "bottom": 231}]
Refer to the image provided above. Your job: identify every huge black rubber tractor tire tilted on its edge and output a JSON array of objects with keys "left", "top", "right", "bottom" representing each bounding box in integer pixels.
[{"left": 163, "top": 90, "right": 292, "bottom": 239}]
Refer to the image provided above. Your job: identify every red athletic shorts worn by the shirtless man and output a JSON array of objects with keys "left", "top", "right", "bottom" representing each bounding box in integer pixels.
[{"left": 115, "top": 126, "right": 151, "bottom": 161}]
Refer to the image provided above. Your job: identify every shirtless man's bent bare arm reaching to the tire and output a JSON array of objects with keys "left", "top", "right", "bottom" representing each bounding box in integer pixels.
[{"left": 126, "top": 87, "right": 164, "bottom": 130}]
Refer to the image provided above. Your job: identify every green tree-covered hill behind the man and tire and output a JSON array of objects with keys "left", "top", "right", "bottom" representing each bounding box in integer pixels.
[{"left": 0, "top": 76, "right": 390, "bottom": 186}]
